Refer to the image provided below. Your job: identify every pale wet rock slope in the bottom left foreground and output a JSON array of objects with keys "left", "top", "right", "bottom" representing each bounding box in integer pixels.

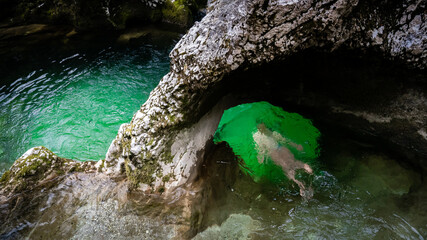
[{"left": 0, "top": 172, "right": 188, "bottom": 239}]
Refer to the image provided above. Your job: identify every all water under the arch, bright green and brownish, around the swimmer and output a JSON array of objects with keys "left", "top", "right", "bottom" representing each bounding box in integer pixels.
[{"left": 206, "top": 102, "right": 427, "bottom": 239}]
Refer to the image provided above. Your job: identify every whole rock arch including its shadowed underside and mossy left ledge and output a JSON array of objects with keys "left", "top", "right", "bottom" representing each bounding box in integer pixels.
[{"left": 0, "top": 0, "right": 427, "bottom": 237}]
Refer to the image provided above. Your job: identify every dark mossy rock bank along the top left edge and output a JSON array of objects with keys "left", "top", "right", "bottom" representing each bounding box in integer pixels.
[{"left": 0, "top": 0, "right": 205, "bottom": 30}]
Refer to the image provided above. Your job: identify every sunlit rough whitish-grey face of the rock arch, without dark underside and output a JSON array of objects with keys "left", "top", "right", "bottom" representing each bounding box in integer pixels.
[{"left": 106, "top": 0, "right": 427, "bottom": 191}]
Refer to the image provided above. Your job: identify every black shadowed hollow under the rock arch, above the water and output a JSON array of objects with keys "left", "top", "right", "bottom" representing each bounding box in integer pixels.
[{"left": 199, "top": 50, "right": 427, "bottom": 171}]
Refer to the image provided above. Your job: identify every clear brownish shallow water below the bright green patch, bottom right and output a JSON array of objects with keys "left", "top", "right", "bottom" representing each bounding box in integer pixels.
[{"left": 196, "top": 130, "right": 427, "bottom": 239}]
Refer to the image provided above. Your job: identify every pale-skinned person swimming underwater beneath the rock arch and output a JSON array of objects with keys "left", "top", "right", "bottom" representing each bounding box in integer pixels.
[{"left": 253, "top": 123, "right": 313, "bottom": 198}]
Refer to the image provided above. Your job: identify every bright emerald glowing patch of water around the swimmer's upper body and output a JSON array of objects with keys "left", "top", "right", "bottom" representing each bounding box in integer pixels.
[{"left": 214, "top": 102, "right": 320, "bottom": 182}]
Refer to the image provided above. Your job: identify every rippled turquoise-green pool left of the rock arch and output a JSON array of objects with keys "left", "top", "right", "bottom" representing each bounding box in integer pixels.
[{"left": 0, "top": 35, "right": 172, "bottom": 173}]
